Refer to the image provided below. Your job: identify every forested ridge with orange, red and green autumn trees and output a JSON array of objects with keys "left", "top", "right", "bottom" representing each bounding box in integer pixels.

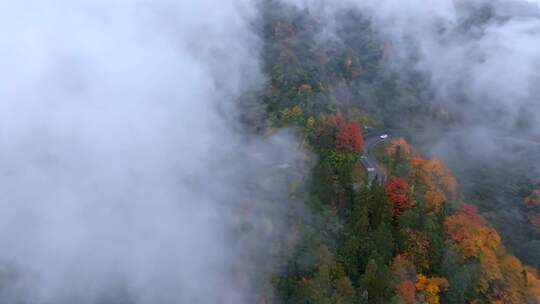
[{"left": 248, "top": 1, "right": 540, "bottom": 304}]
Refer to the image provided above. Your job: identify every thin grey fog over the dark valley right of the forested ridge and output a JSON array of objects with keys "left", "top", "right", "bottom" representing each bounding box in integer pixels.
[{"left": 289, "top": 0, "right": 540, "bottom": 267}]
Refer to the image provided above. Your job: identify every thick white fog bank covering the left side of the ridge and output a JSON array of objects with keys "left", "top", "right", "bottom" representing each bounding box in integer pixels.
[{"left": 0, "top": 0, "right": 304, "bottom": 304}]
